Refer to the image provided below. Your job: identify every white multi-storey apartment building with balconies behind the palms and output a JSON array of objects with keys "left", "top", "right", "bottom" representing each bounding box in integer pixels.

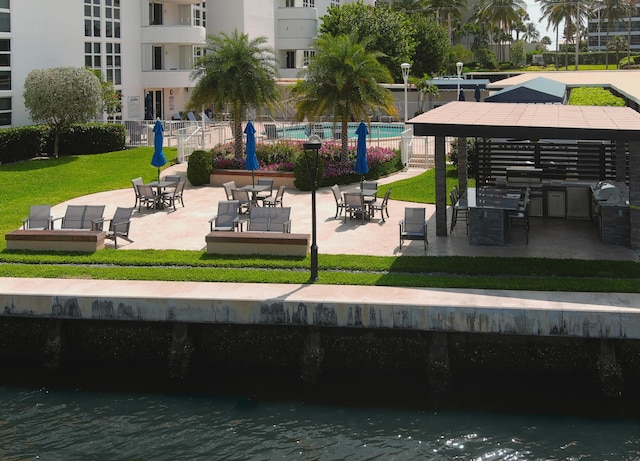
[{"left": 6, "top": 0, "right": 374, "bottom": 127}]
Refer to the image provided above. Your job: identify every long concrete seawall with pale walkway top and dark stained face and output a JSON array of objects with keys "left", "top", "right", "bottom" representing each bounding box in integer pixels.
[{"left": 0, "top": 278, "right": 640, "bottom": 395}]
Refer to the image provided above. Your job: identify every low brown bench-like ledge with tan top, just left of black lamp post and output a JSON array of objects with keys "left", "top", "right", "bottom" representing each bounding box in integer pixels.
[{"left": 205, "top": 231, "right": 310, "bottom": 256}]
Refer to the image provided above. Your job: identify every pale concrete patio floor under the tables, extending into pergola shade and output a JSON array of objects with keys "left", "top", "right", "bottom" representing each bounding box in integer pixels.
[{"left": 53, "top": 164, "right": 638, "bottom": 261}]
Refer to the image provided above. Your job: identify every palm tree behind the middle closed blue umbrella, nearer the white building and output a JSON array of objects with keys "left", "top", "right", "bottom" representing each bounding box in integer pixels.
[{"left": 187, "top": 30, "right": 279, "bottom": 158}]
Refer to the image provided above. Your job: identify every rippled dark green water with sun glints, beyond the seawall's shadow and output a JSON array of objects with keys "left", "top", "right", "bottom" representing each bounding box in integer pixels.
[{"left": 0, "top": 388, "right": 640, "bottom": 461}]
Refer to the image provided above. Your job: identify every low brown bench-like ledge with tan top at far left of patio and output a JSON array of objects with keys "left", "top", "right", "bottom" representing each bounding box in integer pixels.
[{"left": 4, "top": 229, "right": 106, "bottom": 252}]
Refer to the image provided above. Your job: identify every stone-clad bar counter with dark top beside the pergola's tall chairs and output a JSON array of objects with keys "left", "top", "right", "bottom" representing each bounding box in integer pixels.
[{"left": 460, "top": 187, "right": 524, "bottom": 246}]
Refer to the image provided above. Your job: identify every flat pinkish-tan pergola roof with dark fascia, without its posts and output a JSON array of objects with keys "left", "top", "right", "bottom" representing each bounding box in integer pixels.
[{"left": 407, "top": 101, "right": 640, "bottom": 141}]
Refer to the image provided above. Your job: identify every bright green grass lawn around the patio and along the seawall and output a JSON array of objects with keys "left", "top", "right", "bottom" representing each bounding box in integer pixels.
[{"left": 0, "top": 148, "right": 640, "bottom": 292}]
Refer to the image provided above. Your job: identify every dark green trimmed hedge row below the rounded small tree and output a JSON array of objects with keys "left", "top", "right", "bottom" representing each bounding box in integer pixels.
[{"left": 0, "top": 123, "right": 126, "bottom": 163}]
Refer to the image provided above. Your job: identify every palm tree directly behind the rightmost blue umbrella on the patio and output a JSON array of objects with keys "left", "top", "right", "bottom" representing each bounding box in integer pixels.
[{"left": 294, "top": 35, "right": 397, "bottom": 161}]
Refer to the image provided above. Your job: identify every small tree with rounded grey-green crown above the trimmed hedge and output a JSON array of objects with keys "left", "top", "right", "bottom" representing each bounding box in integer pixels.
[{"left": 23, "top": 67, "right": 103, "bottom": 157}]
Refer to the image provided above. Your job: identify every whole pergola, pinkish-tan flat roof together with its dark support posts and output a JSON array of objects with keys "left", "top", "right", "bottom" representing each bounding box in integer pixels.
[{"left": 407, "top": 101, "right": 640, "bottom": 249}]
